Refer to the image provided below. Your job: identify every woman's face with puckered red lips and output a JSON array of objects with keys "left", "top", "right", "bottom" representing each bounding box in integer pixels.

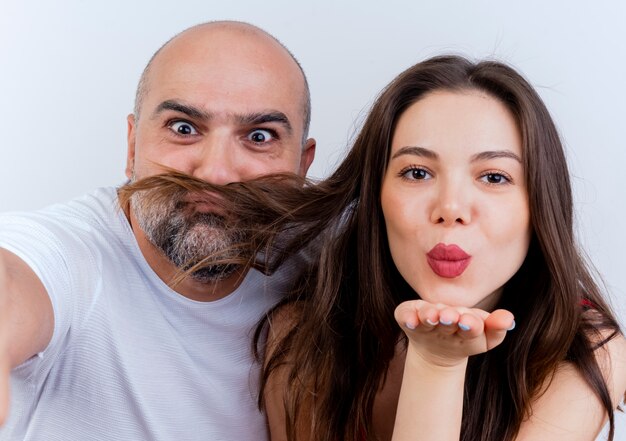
[{"left": 381, "top": 90, "right": 531, "bottom": 310}]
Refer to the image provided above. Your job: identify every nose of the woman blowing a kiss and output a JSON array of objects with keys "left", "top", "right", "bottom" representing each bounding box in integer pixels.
[{"left": 430, "top": 177, "right": 472, "bottom": 226}]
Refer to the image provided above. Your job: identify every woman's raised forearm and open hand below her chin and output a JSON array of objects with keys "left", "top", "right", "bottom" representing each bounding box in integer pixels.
[{"left": 392, "top": 300, "right": 515, "bottom": 441}]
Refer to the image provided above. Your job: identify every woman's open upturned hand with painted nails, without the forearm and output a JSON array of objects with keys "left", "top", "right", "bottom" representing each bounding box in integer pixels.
[{"left": 395, "top": 300, "right": 515, "bottom": 367}]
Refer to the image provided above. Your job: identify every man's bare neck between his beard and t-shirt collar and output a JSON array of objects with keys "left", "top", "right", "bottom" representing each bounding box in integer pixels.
[{"left": 124, "top": 209, "right": 246, "bottom": 302}]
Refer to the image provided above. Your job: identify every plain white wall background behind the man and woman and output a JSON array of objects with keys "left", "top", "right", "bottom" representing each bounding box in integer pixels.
[{"left": 0, "top": 0, "right": 626, "bottom": 440}]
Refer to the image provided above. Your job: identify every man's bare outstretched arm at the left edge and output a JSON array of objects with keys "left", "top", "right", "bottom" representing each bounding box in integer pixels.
[{"left": 0, "top": 248, "right": 54, "bottom": 424}]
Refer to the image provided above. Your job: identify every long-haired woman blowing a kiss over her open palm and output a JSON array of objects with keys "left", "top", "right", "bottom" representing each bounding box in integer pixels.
[{"left": 120, "top": 56, "right": 626, "bottom": 441}]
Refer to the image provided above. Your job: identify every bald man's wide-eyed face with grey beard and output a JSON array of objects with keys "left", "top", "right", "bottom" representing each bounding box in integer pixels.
[{"left": 126, "top": 29, "right": 315, "bottom": 281}]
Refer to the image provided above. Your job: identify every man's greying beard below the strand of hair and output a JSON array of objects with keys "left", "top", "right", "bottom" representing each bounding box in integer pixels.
[{"left": 130, "top": 185, "right": 245, "bottom": 283}]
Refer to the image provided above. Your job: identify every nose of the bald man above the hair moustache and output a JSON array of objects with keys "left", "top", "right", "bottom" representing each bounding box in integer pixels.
[{"left": 192, "top": 135, "right": 241, "bottom": 185}]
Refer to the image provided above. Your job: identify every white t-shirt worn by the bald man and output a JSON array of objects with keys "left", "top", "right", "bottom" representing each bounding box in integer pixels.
[{"left": 0, "top": 188, "right": 291, "bottom": 441}]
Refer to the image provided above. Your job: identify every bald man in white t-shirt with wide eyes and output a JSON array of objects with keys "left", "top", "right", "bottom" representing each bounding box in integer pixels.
[{"left": 0, "top": 22, "right": 315, "bottom": 441}]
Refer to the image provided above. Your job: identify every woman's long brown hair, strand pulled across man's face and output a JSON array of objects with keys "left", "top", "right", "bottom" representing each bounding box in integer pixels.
[{"left": 118, "top": 56, "right": 619, "bottom": 441}]
